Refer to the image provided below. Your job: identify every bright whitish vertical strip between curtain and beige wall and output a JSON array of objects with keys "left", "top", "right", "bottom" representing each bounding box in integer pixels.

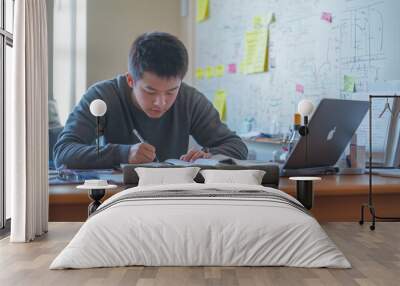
[{"left": 53, "top": 0, "right": 86, "bottom": 125}]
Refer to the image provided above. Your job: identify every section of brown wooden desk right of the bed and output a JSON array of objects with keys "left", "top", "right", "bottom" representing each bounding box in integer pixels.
[{"left": 279, "top": 175, "right": 400, "bottom": 222}]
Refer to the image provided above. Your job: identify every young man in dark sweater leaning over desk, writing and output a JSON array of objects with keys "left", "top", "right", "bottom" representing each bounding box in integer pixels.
[{"left": 54, "top": 32, "right": 247, "bottom": 169}]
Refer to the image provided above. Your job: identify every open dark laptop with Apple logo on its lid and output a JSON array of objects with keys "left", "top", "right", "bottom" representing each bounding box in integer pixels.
[{"left": 282, "top": 98, "right": 369, "bottom": 175}]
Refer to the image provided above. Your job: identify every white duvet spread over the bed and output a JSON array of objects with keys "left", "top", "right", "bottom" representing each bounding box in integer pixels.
[{"left": 50, "top": 183, "right": 351, "bottom": 269}]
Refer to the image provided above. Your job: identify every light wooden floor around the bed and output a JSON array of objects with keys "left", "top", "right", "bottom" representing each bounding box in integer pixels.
[{"left": 0, "top": 222, "right": 400, "bottom": 286}]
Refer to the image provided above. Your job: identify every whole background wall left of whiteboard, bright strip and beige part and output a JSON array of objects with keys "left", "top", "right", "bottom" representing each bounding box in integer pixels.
[{"left": 49, "top": 0, "right": 191, "bottom": 125}]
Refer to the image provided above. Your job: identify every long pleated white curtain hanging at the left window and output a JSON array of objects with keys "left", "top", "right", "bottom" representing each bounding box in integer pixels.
[{"left": 6, "top": 0, "right": 48, "bottom": 242}]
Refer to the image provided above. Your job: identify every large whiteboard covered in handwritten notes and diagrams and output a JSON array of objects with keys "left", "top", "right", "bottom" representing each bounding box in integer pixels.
[{"left": 194, "top": 0, "right": 400, "bottom": 152}]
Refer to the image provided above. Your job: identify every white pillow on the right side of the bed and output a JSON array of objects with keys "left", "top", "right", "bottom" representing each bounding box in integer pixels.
[{"left": 200, "top": 170, "right": 265, "bottom": 185}]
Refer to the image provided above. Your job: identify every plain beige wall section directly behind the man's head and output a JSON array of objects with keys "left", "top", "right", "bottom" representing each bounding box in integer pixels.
[{"left": 87, "top": 0, "right": 183, "bottom": 86}]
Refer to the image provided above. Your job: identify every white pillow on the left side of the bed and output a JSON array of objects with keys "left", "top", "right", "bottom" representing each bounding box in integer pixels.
[{"left": 135, "top": 167, "right": 200, "bottom": 186}]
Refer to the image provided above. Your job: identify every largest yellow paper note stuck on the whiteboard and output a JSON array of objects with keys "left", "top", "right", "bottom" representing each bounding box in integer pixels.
[{"left": 243, "top": 29, "right": 268, "bottom": 73}]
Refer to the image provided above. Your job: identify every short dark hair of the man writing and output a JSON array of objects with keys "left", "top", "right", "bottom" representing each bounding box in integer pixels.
[{"left": 128, "top": 32, "right": 188, "bottom": 80}]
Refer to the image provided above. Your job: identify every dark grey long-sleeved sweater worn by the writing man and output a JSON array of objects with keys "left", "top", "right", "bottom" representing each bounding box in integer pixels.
[{"left": 54, "top": 75, "right": 247, "bottom": 169}]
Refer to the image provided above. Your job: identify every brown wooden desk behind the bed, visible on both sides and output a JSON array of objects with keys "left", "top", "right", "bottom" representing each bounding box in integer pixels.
[{"left": 49, "top": 175, "right": 400, "bottom": 222}]
